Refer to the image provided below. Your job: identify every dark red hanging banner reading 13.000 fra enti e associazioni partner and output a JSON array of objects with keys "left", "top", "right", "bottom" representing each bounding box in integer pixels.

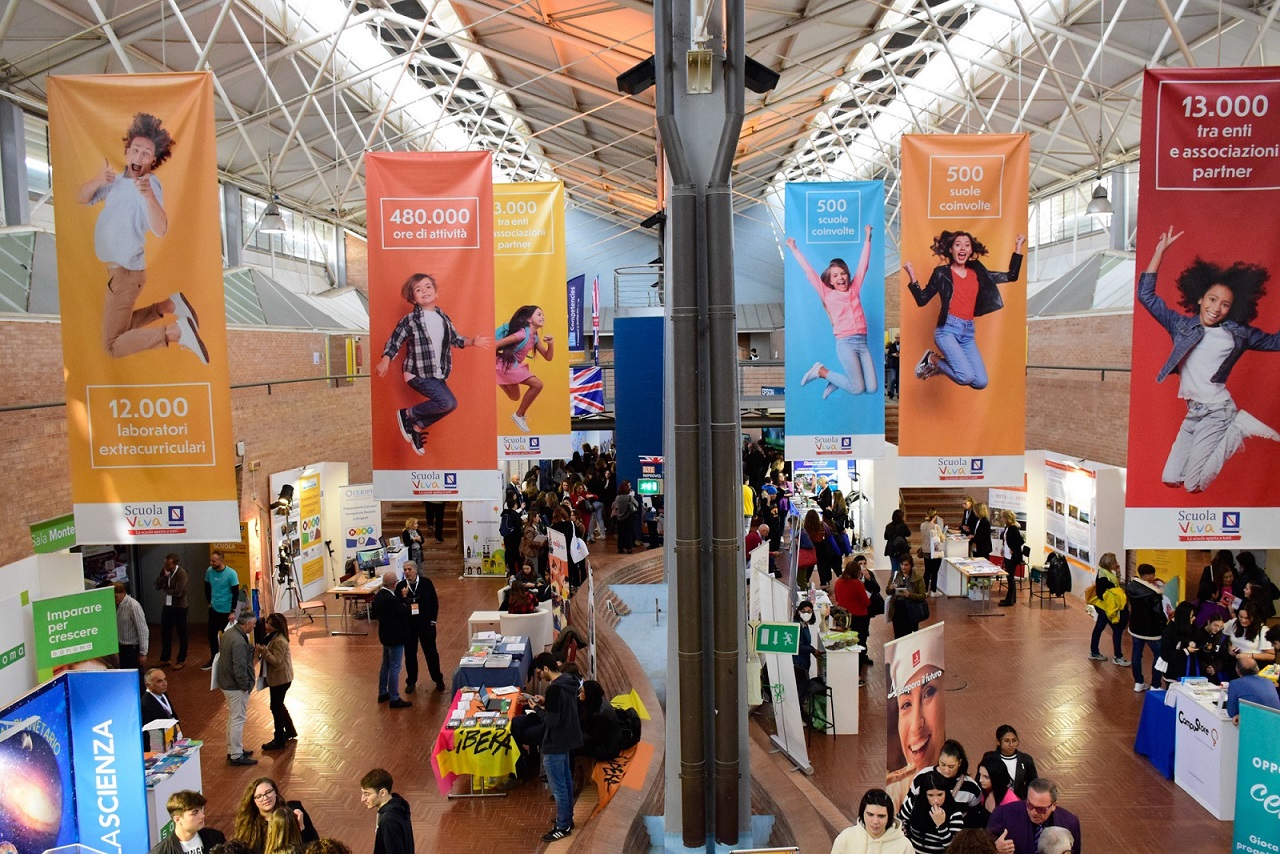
[{"left": 1124, "top": 68, "right": 1280, "bottom": 549}]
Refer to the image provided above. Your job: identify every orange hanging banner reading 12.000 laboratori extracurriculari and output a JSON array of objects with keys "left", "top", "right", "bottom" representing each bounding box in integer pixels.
[{"left": 49, "top": 73, "right": 239, "bottom": 543}]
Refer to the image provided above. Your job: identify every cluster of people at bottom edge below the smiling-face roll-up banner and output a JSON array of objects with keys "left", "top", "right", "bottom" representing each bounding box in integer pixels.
[{"left": 831, "top": 723, "right": 1082, "bottom": 854}]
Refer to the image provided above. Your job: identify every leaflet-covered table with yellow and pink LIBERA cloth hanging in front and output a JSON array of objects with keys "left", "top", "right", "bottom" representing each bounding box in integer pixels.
[{"left": 431, "top": 685, "right": 521, "bottom": 798}]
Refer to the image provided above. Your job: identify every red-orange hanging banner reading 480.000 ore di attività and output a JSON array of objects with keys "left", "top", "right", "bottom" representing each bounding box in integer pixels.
[{"left": 365, "top": 151, "right": 496, "bottom": 501}]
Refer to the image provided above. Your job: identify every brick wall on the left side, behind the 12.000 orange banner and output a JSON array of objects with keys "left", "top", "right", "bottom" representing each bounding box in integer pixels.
[{"left": 0, "top": 321, "right": 372, "bottom": 565}]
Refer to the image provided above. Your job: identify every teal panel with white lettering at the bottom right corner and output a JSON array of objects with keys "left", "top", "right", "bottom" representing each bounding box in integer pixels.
[{"left": 1231, "top": 703, "right": 1280, "bottom": 854}]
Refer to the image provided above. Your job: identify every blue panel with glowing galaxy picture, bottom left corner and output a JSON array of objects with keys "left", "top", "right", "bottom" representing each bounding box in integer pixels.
[{"left": 0, "top": 676, "right": 75, "bottom": 854}]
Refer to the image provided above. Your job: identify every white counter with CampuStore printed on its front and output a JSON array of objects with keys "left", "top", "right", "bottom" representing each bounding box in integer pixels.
[{"left": 1166, "top": 682, "right": 1240, "bottom": 822}]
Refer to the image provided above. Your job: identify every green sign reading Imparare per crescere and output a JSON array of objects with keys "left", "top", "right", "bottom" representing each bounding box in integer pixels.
[{"left": 31, "top": 588, "right": 120, "bottom": 671}]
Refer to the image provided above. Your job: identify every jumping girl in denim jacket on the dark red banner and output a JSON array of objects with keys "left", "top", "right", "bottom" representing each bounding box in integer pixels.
[{"left": 1138, "top": 228, "right": 1280, "bottom": 493}]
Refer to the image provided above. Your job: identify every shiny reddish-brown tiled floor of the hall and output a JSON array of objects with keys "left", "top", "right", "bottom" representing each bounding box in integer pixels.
[{"left": 170, "top": 544, "right": 1231, "bottom": 854}]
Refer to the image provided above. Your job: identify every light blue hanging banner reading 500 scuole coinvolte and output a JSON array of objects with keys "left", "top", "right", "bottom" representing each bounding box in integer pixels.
[{"left": 783, "top": 181, "right": 884, "bottom": 460}]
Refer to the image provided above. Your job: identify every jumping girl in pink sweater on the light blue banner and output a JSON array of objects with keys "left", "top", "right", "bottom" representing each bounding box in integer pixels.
[{"left": 787, "top": 225, "right": 879, "bottom": 399}]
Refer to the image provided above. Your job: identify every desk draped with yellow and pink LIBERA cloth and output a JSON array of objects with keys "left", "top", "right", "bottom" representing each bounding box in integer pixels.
[{"left": 431, "top": 690, "right": 521, "bottom": 798}]
